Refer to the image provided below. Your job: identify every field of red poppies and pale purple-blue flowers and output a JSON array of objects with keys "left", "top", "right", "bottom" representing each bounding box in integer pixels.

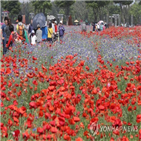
[{"left": 0, "top": 27, "right": 141, "bottom": 141}]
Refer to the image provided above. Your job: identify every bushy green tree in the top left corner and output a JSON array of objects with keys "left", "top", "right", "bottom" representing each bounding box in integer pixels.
[{"left": 2, "top": 0, "right": 21, "bottom": 19}]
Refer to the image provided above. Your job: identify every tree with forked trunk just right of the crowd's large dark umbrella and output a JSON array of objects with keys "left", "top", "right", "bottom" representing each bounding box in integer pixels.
[{"left": 55, "top": 0, "right": 75, "bottom": 22}]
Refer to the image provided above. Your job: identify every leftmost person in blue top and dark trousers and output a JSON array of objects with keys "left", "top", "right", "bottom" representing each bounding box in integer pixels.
[{"left": 1, "top": 17, "right": 8, "bottom": 55}]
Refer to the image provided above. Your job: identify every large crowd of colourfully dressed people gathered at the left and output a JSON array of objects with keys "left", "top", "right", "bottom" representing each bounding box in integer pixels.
[{"left": 1, "top": 15, "right": 65, "bottom": 55}]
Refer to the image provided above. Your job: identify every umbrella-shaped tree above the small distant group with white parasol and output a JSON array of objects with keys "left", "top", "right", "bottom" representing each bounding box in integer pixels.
[{"left": 85, "top": 0, "right": 111, "bottom": 20}]
